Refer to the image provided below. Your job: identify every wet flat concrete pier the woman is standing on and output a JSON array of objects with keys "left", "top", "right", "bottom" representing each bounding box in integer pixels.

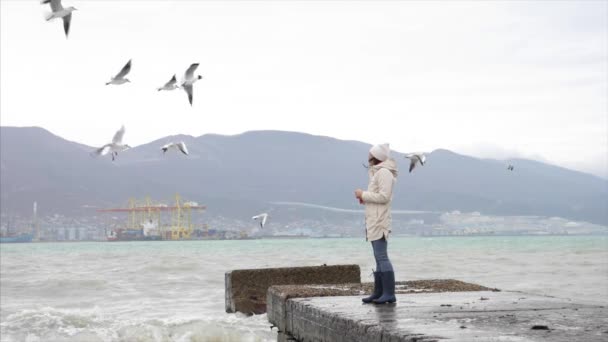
[{"left": 268, "top": 283, "right": 608, "bottom": 342}]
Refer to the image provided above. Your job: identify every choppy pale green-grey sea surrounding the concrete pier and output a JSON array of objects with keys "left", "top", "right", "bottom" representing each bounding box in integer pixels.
[{"left": 0, "top": 236, "right": 608, "bottom": 342}]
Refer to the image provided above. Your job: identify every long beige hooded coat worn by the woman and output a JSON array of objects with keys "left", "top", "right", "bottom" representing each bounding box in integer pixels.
[{"left": 361, "top": 159, "right": 398, "bottom": 241}]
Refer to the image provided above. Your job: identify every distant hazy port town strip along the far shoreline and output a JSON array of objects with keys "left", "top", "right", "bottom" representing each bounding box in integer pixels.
[{"left": 0, "top": 203, "right": 608, "bottom": 242}]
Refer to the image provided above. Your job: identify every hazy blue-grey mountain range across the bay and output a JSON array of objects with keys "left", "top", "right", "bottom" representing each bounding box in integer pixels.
[{"left": 0, "top": 127, "right": 608, "bottom": 225}]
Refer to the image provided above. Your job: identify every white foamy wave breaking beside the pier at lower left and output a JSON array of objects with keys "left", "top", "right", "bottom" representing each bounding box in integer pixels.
[{"left": 0, "top": 307, "right": 276, "bottom": 342}]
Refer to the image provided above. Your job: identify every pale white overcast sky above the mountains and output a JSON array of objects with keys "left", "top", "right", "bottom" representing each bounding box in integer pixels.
[{"left": 0, "top": 0, "right": 608, "bottom": 177}]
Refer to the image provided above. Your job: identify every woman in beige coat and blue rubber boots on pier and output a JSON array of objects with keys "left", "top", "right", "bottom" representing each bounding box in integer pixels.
[{"left": 355, "top": 144, "right": 398, "bottom": 304}]
